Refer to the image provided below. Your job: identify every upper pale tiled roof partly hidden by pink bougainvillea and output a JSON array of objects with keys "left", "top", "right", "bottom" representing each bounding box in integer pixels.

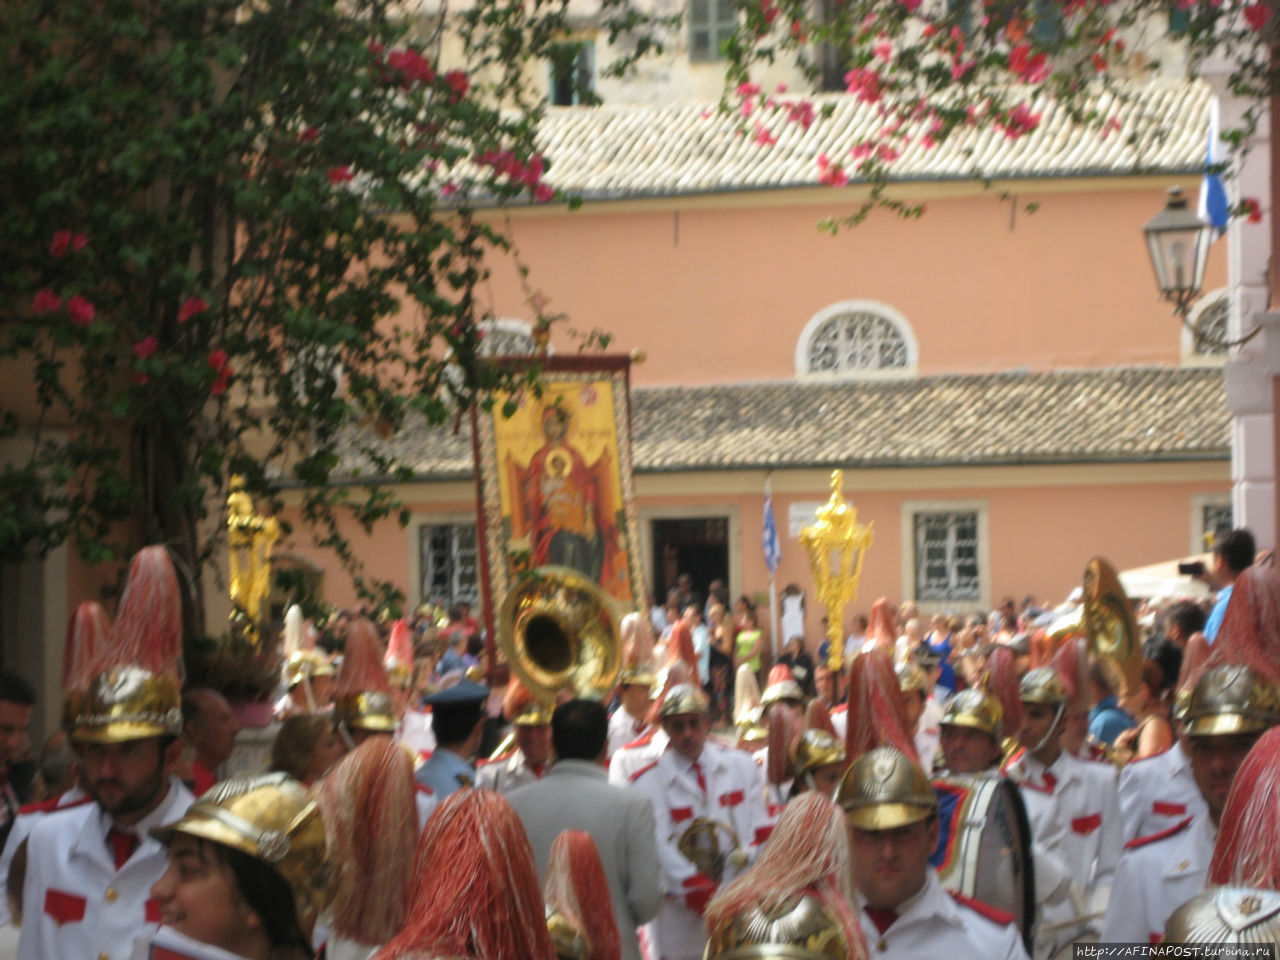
[{"left": 539, "top": 79, "right": 1210, "bottom": 200}]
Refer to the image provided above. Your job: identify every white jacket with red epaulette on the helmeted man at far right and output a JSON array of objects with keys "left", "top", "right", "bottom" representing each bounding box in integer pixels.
[{"left": 1101, "top": 814, "right": 1217, "bottom": 943}]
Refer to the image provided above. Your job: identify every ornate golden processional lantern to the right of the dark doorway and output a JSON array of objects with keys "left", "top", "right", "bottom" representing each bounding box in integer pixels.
[{"left": 800, "top": 470, "right": 872, "bottom": 672}]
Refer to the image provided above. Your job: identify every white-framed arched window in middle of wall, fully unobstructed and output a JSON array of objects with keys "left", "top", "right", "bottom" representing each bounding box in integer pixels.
[{"left": 796, "top": 300, "right": 916, "bottom": 376}]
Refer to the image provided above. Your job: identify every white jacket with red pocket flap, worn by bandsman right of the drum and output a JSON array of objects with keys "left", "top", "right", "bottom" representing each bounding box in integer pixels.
[{"left": 1006, "top": 750, "right": 1124, "bottom": 911}]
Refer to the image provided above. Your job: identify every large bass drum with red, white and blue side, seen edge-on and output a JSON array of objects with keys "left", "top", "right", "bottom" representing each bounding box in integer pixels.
[{"left": 929, "top": 772, "right": 1036, "bottom": 952}]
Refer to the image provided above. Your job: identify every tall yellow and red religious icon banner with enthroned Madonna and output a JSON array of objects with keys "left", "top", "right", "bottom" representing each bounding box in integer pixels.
[{"left": 474, "top": 356, "right": 643, "bottom": 632}]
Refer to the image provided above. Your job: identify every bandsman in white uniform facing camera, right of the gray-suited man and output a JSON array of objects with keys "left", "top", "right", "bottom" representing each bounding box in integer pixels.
[{"left": 631, "top": 684, "right": 771, "bottom": 960}]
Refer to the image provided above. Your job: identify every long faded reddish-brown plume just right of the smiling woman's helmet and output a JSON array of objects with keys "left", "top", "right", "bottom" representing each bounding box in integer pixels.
[{"left": 316, "top": 737, "right": 424, "bottom": 960}]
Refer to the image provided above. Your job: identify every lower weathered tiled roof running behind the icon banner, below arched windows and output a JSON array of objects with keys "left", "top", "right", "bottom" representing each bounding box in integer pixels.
[{"left": 339, "top": 367, "right": 1230, "bottom": 480}]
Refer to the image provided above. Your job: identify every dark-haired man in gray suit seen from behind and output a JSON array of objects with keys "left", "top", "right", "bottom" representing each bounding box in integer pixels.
[{"left": 507, "top": 700, "right": 663, "bottom": 960}]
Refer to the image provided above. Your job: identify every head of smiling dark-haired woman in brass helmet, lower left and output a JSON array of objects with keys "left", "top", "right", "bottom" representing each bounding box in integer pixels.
[{"left": 146, "top": 773, "right": 329, "bottom": 960}]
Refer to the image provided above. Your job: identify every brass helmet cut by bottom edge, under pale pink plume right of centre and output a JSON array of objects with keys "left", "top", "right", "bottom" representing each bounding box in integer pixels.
[{"left": 705, "top": 893, "right": 854, "bottom": 960}]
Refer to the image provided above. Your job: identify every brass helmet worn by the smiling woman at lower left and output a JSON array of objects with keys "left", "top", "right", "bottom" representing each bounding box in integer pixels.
[{"left": 151, "top": 773, "right": 329, "bottom": 940}]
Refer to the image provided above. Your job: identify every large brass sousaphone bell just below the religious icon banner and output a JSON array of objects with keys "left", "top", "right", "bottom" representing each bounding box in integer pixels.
[{"left": 498, "top": 567, "right": 622, "bottom": 703}]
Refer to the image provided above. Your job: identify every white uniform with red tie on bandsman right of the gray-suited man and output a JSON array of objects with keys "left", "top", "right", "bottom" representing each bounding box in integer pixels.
[{"left": 631, "top": 741, "right": 773, "bottom": 960}]
